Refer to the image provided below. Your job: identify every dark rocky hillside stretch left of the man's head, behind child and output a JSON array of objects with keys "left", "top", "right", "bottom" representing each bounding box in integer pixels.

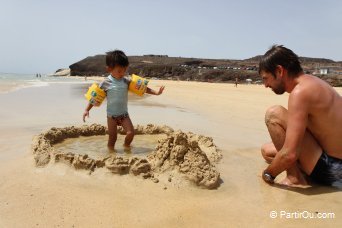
[{"left": 69, "top": 55, "right": 258, "bottom": 81}]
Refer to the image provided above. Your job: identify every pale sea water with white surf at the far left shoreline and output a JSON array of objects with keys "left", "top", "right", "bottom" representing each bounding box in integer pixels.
[{"left": 0, "top": 72, "right": 82, "bottom": 93}]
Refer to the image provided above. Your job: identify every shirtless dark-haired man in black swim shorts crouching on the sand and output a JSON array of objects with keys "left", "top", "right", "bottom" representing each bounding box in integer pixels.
[{"left": 259, "top": 45, "right": 342, "bottom": 186}]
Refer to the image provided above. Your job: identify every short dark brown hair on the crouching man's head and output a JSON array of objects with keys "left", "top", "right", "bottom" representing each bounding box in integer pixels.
[{"left": 259, "top": 45, "right": 303, "bottom": 77}]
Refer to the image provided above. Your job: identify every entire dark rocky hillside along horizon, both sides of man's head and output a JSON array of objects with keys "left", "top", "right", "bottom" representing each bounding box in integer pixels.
[{"left": 69, "top": 55, "right": 342, "bottom": 86}]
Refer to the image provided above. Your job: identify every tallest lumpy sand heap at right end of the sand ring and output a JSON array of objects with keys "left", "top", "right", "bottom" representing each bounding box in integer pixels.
[{"left": 148, "top": 131, "right": 220, "bottom": 189}]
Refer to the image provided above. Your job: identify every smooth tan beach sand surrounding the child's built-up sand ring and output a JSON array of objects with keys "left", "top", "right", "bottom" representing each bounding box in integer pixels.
[{"left": 0, "top": 81, "right": 342, "bottom": 227}]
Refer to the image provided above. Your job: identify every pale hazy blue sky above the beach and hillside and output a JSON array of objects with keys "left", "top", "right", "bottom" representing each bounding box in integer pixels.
[{"left": 0, "top": 0, "right": 342, "bottom": 74}]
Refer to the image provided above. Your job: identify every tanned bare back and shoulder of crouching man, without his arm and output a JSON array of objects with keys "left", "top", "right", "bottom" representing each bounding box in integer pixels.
[{"left": 289, "top": 75, "right": 342, "bottom": 159}]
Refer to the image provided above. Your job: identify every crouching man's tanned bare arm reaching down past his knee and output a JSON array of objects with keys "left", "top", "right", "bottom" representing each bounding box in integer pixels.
[{"left": 264, "top": 89, "right": 310, "bottom": 180}]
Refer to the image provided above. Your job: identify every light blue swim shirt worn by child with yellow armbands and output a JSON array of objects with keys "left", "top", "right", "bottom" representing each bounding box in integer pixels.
[{"left": 100, "top": 75, "right": 131, "bottom": 117}]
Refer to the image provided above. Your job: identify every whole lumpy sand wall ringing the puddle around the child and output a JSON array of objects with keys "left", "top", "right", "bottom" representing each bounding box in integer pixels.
[{"left": 32, "top": 124, "right": 222, "bottom": 189}]
